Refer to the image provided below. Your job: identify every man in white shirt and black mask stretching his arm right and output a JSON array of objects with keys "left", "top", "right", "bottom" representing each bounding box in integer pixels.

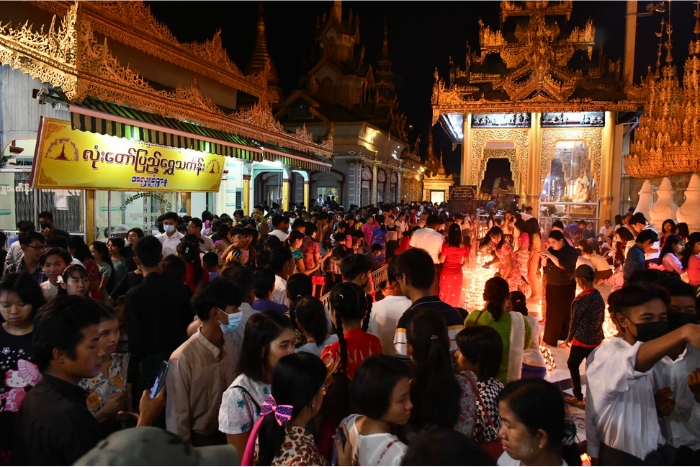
[{"left": 586, "top": 283, "right": 700, "bottom": 465}]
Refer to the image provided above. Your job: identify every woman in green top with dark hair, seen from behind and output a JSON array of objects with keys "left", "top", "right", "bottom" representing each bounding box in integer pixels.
[{"left": 464, "top": 277, "right": 532, "bottom": 384}]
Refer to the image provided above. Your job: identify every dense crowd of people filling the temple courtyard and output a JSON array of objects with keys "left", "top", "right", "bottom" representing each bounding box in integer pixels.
[{"left": 0, "top": 200, "right": 700, "bottom": 465}]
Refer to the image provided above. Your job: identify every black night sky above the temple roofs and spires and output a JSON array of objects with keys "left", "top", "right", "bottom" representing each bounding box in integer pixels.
[{"left": 146, "top": 1, "right": 695, "bottom": 177}]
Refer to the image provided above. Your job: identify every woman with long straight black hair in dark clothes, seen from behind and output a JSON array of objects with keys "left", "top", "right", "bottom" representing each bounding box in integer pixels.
[{"left": 405, "top": 308, "right": 476, "bottom": 441}]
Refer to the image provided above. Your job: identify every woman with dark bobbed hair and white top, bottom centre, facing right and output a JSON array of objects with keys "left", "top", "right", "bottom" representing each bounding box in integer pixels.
[{"left": 336, "top": 355, "right": 413, "bottom": 465}]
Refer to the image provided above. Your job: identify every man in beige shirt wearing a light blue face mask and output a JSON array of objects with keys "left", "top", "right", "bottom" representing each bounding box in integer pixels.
[{"left": 165, "top": 278, "right": 243, "bottom": 447}]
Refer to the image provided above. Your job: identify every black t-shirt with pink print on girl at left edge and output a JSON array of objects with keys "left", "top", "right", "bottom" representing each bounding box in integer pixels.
[{"left": 0, "top": 324, "right": 35, "bottom": 451}]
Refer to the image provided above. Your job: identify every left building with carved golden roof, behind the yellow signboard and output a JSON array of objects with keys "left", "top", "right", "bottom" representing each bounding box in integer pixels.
[{"left": 0, "top": 1, "right": 333, "bottom": 238}]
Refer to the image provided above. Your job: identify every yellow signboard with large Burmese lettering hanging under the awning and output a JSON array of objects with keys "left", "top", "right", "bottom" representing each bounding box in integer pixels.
[{"left": 31, "top": 117, "right": 225, "bottom": 192}]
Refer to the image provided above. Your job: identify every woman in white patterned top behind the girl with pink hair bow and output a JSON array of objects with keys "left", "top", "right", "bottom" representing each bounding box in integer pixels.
[{"left": 219, "top": 311, "right": 294, "bottom": 452}]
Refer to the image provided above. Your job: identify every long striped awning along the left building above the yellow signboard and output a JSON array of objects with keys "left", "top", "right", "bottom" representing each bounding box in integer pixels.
[{"left": 70, "top": 96, "right": 331, "bottom": 172}]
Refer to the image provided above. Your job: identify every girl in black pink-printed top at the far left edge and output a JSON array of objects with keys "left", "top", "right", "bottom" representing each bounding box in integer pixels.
[{"left": 0, "top": 272, "right": 46, "bottom": 465}]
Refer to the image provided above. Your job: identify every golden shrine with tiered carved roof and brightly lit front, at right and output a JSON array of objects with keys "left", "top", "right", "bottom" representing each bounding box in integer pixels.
[{"left": 432, "top": 1, "right": 642, "bottom": 223}]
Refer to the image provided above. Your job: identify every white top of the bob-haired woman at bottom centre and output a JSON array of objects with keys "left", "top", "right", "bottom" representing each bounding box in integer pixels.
[{"left": 341, "top": 414, "right": 408, "bottom": 465}]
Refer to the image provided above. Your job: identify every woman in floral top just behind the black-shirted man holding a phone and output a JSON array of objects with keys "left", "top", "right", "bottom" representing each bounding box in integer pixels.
[{"left": 79, "top": 303, "right": 129, "bottom": 421}]
